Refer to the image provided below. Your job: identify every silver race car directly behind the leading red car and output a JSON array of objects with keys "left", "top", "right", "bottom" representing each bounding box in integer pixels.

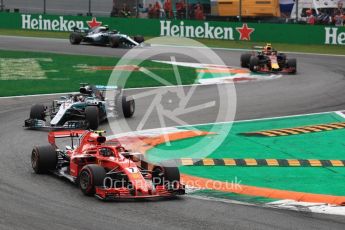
[{"left": 24, "top": 83, "right": 135, "bottom": 130}]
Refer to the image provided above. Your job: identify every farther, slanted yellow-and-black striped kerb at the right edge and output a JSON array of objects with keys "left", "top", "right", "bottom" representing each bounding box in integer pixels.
[{"left": 241, "top": 122, "right": 345, "bottom": 137}]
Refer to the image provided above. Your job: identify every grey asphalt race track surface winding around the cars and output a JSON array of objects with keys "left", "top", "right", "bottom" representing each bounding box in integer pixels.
[{"left": 0, "top": 36, "right": 345, "bottom": 230}]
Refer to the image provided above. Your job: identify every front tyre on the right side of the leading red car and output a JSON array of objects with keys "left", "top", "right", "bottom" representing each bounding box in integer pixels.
[{"left": 152, "top": 166, "right": 180, "bottom": 189}]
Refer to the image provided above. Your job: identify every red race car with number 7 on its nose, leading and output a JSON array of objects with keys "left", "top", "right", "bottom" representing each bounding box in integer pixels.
[{"left": 31, "top": 130, "right": 185, "bottom": 200}]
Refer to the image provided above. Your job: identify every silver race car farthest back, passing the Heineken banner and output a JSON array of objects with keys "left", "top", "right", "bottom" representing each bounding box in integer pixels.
[{"left": 69, "top": 26, "right": 144, "bottom": 48}]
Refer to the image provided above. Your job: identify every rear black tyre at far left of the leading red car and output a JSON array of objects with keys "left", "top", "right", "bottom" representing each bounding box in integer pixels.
[{"left": 31, "top": 145, "right": 57, "bottom": 174}]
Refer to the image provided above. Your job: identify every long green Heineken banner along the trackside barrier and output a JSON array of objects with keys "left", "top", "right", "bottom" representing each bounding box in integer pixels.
[{"left": 0, "top": 13, "right": 345, "bottom": 45}]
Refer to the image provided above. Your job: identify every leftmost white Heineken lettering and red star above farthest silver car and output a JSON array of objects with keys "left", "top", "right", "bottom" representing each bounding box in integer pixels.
[{"left": 21, "top": 14, "right": 102, "bottom": 31}]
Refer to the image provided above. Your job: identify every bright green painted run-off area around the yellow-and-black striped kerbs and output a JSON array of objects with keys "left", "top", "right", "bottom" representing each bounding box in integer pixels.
[{"left": 149, "top": 113, "right": 345, "bottom": 200}]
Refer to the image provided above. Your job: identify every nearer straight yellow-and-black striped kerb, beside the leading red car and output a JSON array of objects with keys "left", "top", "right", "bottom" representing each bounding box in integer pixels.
[{"left": 169, "top": 158, "right": 345, "bottom": 167}]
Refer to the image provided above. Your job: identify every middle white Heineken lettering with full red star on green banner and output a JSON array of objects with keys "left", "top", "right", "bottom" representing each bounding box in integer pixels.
[{"left": 160, "top": 21, "right": 255, "bottom": 40}]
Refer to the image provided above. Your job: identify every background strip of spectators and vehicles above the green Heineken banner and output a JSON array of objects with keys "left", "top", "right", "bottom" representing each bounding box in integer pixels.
[{"left": 0, "top": 0, "right": 345, "bottom": 26}]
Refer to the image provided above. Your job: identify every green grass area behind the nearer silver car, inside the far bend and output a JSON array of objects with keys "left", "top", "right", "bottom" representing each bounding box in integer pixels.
[{"left": 0, "top": 50, "right": 196, "bottom": 96}]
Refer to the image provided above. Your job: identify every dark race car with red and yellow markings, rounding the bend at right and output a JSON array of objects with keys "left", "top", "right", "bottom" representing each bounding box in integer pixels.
[{"left": 241, "top": 43, "right": 297, "bottom": 74}]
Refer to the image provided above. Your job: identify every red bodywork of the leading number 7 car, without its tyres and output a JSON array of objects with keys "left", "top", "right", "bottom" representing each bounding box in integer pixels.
[{"left": 48, "top": 130, "right": 184, "bottom": 199}]
